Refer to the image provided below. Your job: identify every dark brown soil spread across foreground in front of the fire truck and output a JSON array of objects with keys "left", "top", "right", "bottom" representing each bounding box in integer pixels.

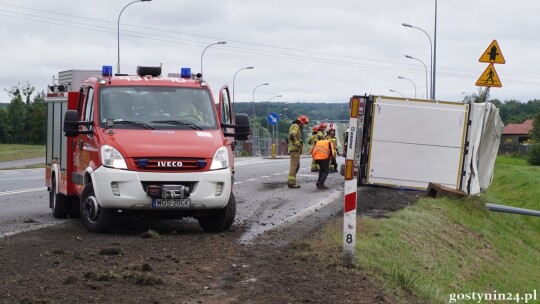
[{"left": 0, "top": 186, "right": 422, "bottom": 303}]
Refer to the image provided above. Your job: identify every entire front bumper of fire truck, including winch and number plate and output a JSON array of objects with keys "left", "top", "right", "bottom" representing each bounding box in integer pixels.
[{"left": 91, "top": 166, "right": 232, "bottom": 210}]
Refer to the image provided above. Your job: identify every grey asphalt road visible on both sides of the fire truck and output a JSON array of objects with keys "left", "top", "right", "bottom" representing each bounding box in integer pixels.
[{"left": 0, "top": 157, "right": 343, "bottom": 243}]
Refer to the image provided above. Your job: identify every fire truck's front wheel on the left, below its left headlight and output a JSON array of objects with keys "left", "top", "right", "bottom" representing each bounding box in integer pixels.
[{"left": 80, "top": 184, "right": 115, "bottom": 233}]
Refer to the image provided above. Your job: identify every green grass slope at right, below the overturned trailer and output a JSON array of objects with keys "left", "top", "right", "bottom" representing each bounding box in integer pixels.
[{"left": 319, "top": 156, "right": 540, "bottom": 303}]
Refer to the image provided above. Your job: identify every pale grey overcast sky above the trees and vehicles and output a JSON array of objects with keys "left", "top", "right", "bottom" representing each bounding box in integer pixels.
[{"left": 0, "top": 0, "right": 540, "bottom": 102}]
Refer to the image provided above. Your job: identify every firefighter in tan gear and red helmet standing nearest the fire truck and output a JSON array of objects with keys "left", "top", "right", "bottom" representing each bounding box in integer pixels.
[{"left": 287, "top": 115, "right": 309, "bottom": 188}]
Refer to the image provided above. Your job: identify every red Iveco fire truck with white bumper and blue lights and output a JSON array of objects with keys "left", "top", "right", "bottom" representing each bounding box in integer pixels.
[{"left": 45, "top": 66, "right": 250, "bottom": 232}]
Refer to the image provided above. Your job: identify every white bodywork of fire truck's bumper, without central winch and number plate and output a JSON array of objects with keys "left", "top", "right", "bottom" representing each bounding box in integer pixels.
[{"left": 91, "top": 166, "right": 232, "bottom": 210}]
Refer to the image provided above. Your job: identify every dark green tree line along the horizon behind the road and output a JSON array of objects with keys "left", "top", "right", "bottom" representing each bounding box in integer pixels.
[{"left": 0, "top": 82, "right": 540, "bottom": 145}]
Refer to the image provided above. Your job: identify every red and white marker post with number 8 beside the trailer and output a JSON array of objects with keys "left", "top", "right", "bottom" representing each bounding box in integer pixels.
[{"left": 343, "top": 96, "right": 360, "bottom": 267}]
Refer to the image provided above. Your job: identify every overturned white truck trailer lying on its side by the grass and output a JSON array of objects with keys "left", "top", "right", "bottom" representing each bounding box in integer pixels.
[{"left": 353, "top": 96, "right": 504, "bottom": 194}]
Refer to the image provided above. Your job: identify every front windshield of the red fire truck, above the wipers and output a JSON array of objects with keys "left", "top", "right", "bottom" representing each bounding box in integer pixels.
[{"left": 98, "top": 86, "right": 217, "bottom": 130}]
